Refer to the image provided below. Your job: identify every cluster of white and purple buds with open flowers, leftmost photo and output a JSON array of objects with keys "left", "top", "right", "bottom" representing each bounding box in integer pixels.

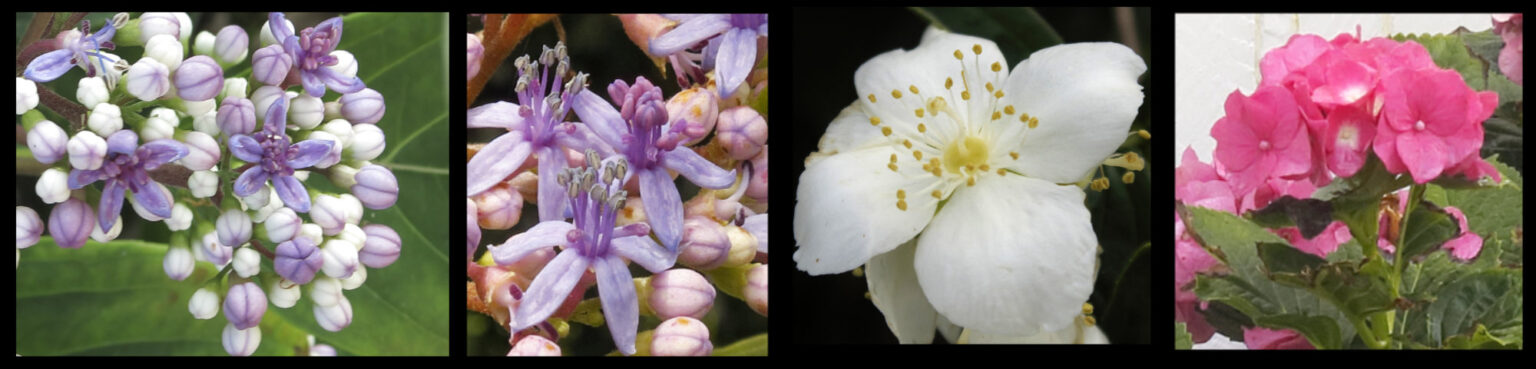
[{"left": 17, "top": 12, "right": 401, "bottom": 355}]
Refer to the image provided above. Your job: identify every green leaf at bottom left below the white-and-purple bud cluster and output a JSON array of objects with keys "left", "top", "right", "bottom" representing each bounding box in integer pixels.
[{"left": 15, "top": 237, "right": 309, "bottom": 357}]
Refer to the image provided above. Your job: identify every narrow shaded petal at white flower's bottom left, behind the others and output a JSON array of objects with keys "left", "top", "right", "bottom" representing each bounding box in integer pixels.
[{"left": 865, "top": 241, "right": 938, "bottom": 343}]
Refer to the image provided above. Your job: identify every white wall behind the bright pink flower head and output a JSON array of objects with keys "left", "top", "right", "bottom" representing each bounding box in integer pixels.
[{"left": 1172, "top": 14, "right": 1493, "bottom": 165}]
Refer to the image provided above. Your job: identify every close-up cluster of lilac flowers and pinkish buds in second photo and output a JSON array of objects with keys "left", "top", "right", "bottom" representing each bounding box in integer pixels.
[{"left": 467, "top": 14, "right": 768, "bottom": 355}]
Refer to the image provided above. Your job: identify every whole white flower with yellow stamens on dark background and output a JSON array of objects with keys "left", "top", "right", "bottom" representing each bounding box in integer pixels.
[{"left": 794, "top": 29, "right": 1146, "bottom": 341}]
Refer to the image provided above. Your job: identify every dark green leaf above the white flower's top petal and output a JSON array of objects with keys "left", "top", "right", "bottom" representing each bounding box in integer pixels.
[{"left": 912, "top": 8, "right": 1061, "bottom": 66}]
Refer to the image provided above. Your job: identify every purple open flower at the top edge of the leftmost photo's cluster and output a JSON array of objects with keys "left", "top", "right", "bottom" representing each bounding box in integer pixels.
[{"left": 267, "top": 12, "right": 366, "bottom": 97}]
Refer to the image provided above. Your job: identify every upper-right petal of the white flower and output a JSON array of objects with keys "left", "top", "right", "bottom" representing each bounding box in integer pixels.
[{"left": 997, "top": 43, "right": 1147, "bottom": 183}]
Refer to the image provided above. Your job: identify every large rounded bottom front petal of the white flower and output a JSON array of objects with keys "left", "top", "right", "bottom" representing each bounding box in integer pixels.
[{"left": 914, "top": 175, "right": 1097, "bottom": 335}]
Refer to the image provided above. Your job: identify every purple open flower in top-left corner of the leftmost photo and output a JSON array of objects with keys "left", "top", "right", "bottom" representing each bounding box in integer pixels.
[{"left": 25, "top": 20, "right": 117, "bottom": 81}]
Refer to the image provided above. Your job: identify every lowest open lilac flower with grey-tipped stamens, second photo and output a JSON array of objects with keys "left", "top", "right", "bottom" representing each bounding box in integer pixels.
[{"left": 490, "top": 151, "right": 676, "bottom": 355}]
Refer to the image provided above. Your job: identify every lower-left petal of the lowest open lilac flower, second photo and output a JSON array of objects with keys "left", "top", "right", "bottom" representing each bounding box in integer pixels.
[{"left": 511, "top": 249, "right": 587, "bottom": 331}]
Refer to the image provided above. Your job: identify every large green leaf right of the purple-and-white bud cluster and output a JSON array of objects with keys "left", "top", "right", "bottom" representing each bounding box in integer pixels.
[{"left": 258, "top": 12, "right": 448, "bottom": 355}]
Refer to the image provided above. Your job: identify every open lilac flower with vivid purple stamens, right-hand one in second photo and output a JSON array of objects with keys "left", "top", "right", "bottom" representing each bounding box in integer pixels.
[{"left": 574, "top": 77, "right": 736, "bottom": 251}]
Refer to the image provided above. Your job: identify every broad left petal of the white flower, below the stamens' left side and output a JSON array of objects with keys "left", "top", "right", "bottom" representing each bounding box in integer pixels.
[{"left": 794, "top": 146, "right": 938, "bottom": 275}]
